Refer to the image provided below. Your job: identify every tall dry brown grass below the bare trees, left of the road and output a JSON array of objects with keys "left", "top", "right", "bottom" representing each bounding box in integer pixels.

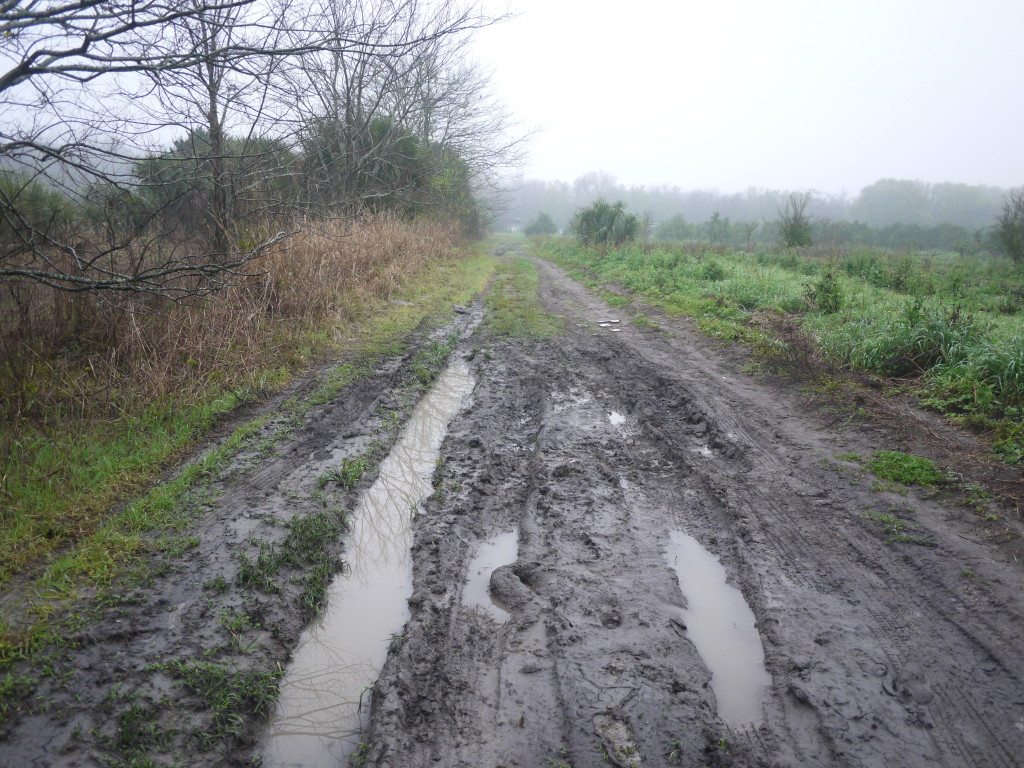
[{"left": 0, "top": 215, "right": 457, "bottom": 425}]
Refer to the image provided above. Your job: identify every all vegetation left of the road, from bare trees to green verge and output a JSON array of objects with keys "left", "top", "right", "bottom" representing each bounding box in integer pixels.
[{"left": 0, "top": 0, "right": 518, "bottom": 662}]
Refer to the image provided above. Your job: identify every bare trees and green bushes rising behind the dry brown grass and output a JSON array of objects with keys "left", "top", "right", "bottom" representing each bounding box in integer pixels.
[{"left": 0, "top": 0, "right": 519, "bottom": 300}]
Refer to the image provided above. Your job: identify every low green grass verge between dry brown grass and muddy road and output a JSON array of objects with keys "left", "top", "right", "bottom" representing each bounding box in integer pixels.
[{"left": 0, "top": 244, "right": 494, "bottom": 666}]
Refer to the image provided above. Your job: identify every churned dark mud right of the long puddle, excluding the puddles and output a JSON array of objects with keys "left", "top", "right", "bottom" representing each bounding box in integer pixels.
[{"left": 364, "top": 253, "right": 1024, "bottom": 768}]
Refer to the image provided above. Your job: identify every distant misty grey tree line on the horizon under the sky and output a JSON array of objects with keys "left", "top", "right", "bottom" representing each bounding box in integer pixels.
[{"left": 496, "top": 172, "right": 1007, "bottom": 252}]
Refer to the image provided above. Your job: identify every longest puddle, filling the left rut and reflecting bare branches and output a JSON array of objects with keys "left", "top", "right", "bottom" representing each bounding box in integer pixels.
[{"left": 262, "top": 360, "right": 473, "bottom": 768}]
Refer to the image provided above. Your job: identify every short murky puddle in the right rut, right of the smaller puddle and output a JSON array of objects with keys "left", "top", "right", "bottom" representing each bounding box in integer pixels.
[{"left": 666, "top": 530, "right": 771, "bottom": 727}]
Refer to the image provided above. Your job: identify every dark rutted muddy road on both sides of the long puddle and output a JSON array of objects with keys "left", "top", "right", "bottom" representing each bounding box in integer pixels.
[{"left": 0, "top": 247, "right": 1024, "bottom": 768}]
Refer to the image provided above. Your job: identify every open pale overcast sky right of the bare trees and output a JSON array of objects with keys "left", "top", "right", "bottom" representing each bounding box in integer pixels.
[{"left": 476, "top": 0, "right": 1024, "bottom": 194}]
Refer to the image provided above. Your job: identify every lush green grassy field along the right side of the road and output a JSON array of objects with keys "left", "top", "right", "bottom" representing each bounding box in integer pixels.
[{"left": 537, "top": 239, "right": 1024, "bottom": 463}]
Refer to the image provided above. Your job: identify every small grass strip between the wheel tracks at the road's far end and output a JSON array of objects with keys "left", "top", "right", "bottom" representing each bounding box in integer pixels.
[{"left": 485, "top": 257, "right": 563, "bottom": 339}]
